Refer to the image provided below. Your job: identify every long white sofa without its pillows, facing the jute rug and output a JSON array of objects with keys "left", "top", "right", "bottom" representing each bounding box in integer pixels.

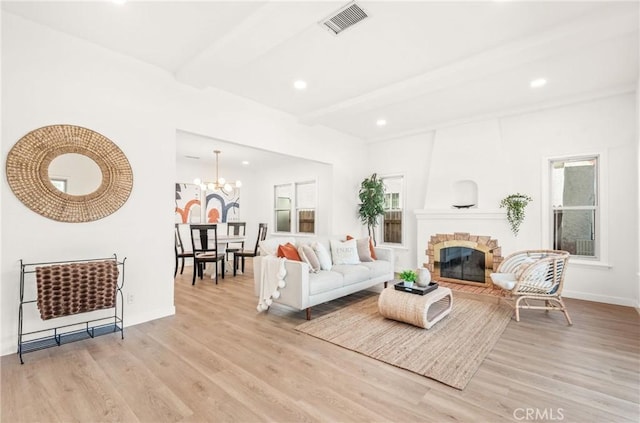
[{"left": 253, "top": 237, "right": 394, "bottom": 320}]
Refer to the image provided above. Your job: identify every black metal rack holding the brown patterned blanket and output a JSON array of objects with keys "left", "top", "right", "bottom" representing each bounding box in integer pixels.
[{"left": 18, "top": 254, "right": 127, "bottom": 364}]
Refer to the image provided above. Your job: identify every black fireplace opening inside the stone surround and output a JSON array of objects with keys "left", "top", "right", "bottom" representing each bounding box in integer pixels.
[{"left": 440, "top": 247, "right": 486, "bottom": 283}]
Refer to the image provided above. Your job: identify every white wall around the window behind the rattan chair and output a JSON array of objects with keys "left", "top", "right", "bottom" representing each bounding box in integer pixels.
[{"left": 502, "top": 93, "right": 639, "bottom": 306}]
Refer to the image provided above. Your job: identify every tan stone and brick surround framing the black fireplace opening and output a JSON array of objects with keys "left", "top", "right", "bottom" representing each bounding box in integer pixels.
[{"left": 424, "top": 232, "right": 503, "bottom": 288}]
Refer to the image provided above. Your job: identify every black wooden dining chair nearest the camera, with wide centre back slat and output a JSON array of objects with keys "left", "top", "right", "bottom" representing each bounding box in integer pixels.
[{"left": 190, "top": 224, "right": 225, "bottom": 285}]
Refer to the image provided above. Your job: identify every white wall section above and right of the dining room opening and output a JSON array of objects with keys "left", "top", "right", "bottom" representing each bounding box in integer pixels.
[{"left": 174, "top": 85, "right": 366, "bottom": 237}]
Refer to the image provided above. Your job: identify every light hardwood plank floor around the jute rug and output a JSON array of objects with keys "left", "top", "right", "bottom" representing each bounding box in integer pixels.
[{"left": 0, "top": 265, "right": 640, "bottom": 423}]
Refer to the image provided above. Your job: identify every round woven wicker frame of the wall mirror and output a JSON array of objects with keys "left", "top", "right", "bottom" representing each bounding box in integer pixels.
[{"left": 6, "top": 125, "right": 133, "bottom": 222}]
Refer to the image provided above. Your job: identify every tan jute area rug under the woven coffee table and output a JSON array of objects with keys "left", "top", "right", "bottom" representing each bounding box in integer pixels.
[{"left": 296, "top": 294, "right": 513, "bottom": 390}]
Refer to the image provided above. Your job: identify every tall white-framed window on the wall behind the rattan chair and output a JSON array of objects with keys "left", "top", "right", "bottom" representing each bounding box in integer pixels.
[{"left": 549, "top": 156, "right": 601, "bottom": 258}]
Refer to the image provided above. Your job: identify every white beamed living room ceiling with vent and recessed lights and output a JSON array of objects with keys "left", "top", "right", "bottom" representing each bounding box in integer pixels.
[{"left": 2, "top": 0, "right": 639, "bottom": 151}]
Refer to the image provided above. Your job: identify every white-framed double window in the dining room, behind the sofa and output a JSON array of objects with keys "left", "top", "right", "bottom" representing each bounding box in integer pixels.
[{"left": 274, "top": 181, "right": 316, "bottom": 234}]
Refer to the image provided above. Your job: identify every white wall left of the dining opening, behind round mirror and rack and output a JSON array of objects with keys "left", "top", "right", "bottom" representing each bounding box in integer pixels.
[{"left": 0, "top": 14, "right": 175, "bottom": 354}]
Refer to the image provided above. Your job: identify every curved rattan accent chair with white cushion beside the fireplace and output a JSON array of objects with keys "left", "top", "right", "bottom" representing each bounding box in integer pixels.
[{"left": 491, "top": 250, "right": 573, "bottom": 325}]
